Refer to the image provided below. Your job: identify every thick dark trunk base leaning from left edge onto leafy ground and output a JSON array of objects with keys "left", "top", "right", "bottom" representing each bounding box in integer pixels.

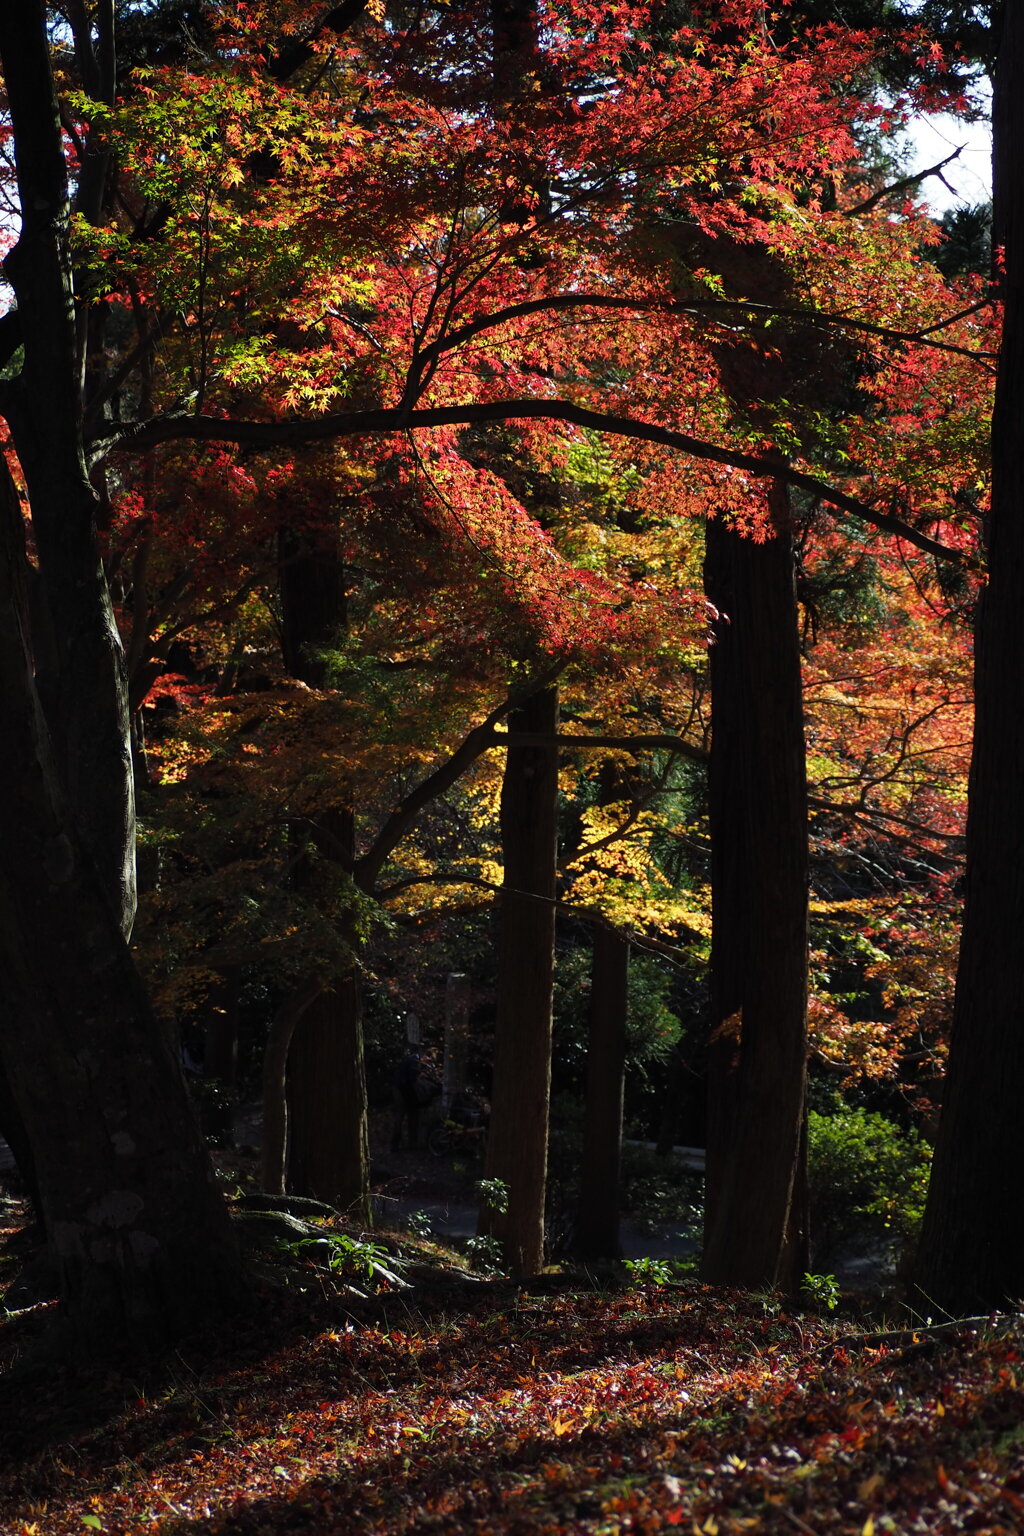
[{"left": 0, "top": 473, "right": 239, "bottom": 1349}]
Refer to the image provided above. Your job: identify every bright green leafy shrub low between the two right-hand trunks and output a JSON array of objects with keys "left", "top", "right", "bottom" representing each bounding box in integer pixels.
[{"left": 808, "top": 1100, "right": 932, "bottom": 1267}]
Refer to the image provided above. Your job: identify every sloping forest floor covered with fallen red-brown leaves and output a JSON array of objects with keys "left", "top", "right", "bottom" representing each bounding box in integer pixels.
[{"left": 0, "top": 1210, "right": 1024, "bottom": 1536}]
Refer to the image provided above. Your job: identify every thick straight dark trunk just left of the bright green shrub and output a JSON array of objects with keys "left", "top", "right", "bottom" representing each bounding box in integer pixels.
[{"left": 703, "top": 484, "right": 808, "bottom": 1292}]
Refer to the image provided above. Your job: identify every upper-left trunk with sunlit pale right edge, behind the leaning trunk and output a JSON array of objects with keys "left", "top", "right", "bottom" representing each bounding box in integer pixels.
[{"left": 0, "top": 0, "right": 135, "bottom": 934}]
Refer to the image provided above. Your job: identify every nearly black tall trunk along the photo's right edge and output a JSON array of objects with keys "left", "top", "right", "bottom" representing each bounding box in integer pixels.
[{"left": 917, "top": 3, "right": 1024, "bottom": 1313}]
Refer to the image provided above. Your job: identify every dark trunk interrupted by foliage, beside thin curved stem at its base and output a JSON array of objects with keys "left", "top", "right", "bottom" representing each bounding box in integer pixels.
[{"left": 281, "top": 531, "right": 370, "bottom": 1226}]
